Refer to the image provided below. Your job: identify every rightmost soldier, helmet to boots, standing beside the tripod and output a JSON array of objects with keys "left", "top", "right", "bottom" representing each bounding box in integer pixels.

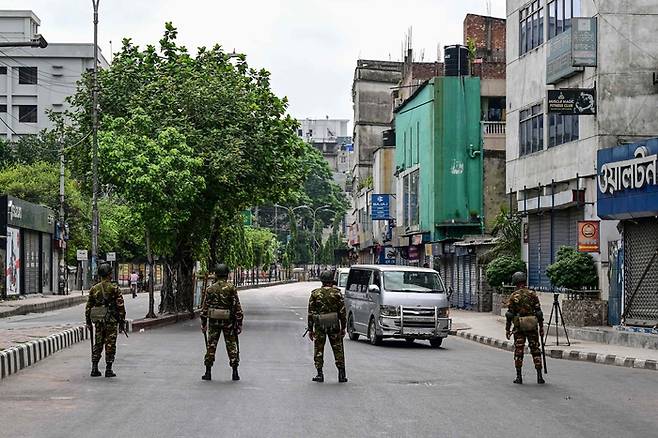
[{"left": 505, "top": 272, "right": 545, "bottom": 384}]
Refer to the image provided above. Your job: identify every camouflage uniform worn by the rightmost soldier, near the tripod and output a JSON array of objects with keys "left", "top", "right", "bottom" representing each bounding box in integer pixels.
[{"left": 505, "top": 288, "right": 544, "bottom": 370}]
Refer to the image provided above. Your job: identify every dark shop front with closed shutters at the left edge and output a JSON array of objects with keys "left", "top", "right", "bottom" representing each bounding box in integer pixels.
[{"left": 0, "top": 196, "right": 55, "bottom": 297}]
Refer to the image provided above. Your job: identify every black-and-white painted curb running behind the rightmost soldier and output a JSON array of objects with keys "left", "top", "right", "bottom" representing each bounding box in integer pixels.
[{"left": 455, "top": 330, "right": 658, "bottom": 371}]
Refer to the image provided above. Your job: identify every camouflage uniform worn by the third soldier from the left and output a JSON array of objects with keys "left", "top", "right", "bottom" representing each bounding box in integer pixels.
[{"left": 308, "top": 286, "right": 347, "bottom": 369}]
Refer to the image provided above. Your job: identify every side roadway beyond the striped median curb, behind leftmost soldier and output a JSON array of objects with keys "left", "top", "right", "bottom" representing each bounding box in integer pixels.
[{"left": 0, "top": 293, "right": 151, "bottom": 329}]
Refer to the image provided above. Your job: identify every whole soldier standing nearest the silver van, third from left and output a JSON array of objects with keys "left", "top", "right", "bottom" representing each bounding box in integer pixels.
[{"left": 308, "top": 271, "right": 347, "bottom": 383}]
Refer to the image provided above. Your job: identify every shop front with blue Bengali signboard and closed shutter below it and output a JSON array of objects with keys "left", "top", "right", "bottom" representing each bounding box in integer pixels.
[{"left": 597, "top": 139, "right": 658, "bottom": 327}]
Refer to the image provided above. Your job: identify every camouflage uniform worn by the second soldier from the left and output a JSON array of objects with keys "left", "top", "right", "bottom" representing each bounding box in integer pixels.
[{"left": 201, "top": 280, "right": 244, "bottom": 367}]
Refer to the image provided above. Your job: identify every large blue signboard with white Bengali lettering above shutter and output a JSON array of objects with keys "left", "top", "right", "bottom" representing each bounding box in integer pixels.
[{"left": 597, "top": 138, "right": 658, "bottom": 219}]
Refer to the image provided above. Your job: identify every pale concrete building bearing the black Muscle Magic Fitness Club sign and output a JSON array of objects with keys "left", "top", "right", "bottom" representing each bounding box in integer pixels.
[{"left": 506, "top": 0, "right": 658, "bottom": 322}]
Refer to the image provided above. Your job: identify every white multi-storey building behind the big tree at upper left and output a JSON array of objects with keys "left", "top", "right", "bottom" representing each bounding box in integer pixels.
[{"left": 0, "top": 11, "right": 109, "bottom": 140}]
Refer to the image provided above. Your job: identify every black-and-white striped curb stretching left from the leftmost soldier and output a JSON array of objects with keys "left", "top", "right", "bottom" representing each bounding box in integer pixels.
[{"left": 0, "top": 326, "right": 89, "bottom": 380}]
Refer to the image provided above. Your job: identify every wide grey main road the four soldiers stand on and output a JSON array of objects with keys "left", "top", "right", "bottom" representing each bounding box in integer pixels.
[{"left": 0, "top": 284, "right": 658, "bottom": 438}]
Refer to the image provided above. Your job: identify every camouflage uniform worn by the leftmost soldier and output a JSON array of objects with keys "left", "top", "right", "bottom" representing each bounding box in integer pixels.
[{"left": 85, "top": 279, "right": 126, "bottom": 363}]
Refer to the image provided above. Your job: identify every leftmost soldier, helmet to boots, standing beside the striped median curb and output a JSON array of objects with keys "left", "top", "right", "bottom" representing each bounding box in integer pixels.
[{"left": 85, "top": 263, "right": 126, "bottom": 377}]
